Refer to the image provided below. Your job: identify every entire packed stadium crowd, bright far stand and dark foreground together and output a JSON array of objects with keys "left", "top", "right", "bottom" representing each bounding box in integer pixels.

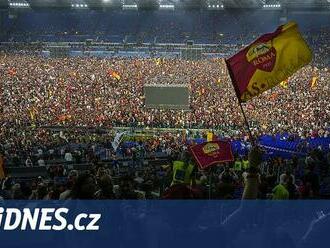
[{"left": 1, "top": 50, "right": 330, "bottom": 199}]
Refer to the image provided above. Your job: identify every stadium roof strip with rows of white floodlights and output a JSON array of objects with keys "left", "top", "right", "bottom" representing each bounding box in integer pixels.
[{"left": 0, "top": 0, "right": 330, "bottom": 9}]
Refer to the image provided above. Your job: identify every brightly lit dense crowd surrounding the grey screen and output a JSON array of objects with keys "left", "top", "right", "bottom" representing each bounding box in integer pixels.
[{"left": 0, "top": 54, "right": 330, "bottom": 136}]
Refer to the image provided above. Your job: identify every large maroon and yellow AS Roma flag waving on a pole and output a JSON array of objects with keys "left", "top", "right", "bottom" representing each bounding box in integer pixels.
[{"left": 226, "top": 22, "right": 312, "bottom": 102}]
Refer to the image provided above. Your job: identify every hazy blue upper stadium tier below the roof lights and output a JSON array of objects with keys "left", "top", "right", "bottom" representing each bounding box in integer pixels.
[{"left": 1, "top": 9, "right": 330, "bottom": 44}]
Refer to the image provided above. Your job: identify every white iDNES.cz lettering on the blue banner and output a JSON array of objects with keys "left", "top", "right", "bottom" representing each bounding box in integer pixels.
[{"left": 0, "top": 207, "right": 101, "bottom": 231}]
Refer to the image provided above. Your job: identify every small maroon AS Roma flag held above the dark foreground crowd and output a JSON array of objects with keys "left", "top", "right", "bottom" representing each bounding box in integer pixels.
[{"left": 190, "top": 141, "right": 234, "bottom": 169}]
